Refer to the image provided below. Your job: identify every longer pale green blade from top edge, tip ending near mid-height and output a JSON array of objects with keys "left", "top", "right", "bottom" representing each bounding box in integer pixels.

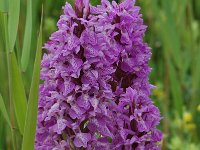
[{"left": 21, "top": 0, "right": 32, "bottom": 72}]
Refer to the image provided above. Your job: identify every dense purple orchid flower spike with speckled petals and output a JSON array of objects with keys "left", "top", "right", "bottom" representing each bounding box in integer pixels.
[{"left": 35, "top": 0, "right": 162, "bottom": 150}]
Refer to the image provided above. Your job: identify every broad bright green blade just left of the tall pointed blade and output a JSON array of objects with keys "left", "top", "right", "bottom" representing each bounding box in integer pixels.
[{"left": 10, "top": 52, "right": 27, "bottom": 135}]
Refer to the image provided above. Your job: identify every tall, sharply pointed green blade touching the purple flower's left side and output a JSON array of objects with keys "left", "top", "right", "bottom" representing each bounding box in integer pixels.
[{"left": 22, "top": 8, "right": 43, "bottom": 150}]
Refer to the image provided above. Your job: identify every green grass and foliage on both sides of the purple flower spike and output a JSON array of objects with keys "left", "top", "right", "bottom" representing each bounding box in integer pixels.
[{"left": 0, "top": 0, "right": 200, "bottom": 150}]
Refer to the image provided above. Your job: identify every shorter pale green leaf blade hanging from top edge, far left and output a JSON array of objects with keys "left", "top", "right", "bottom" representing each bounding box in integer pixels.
[{"left": 8, "top": 0, "right": 20, "bottom": 52}]
